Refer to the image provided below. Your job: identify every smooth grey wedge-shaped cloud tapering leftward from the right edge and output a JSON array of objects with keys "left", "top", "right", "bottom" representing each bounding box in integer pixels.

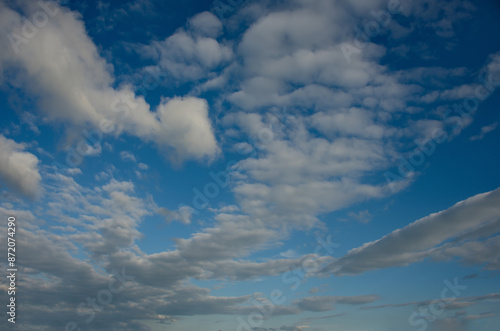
[{"left": 325, "top": 189, "right": 500, "bottom": 275}]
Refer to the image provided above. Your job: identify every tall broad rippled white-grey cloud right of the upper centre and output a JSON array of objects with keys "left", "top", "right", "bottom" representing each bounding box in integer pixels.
[{"left": 216, "top": 1, "right": 496, "bottom": 236}]
